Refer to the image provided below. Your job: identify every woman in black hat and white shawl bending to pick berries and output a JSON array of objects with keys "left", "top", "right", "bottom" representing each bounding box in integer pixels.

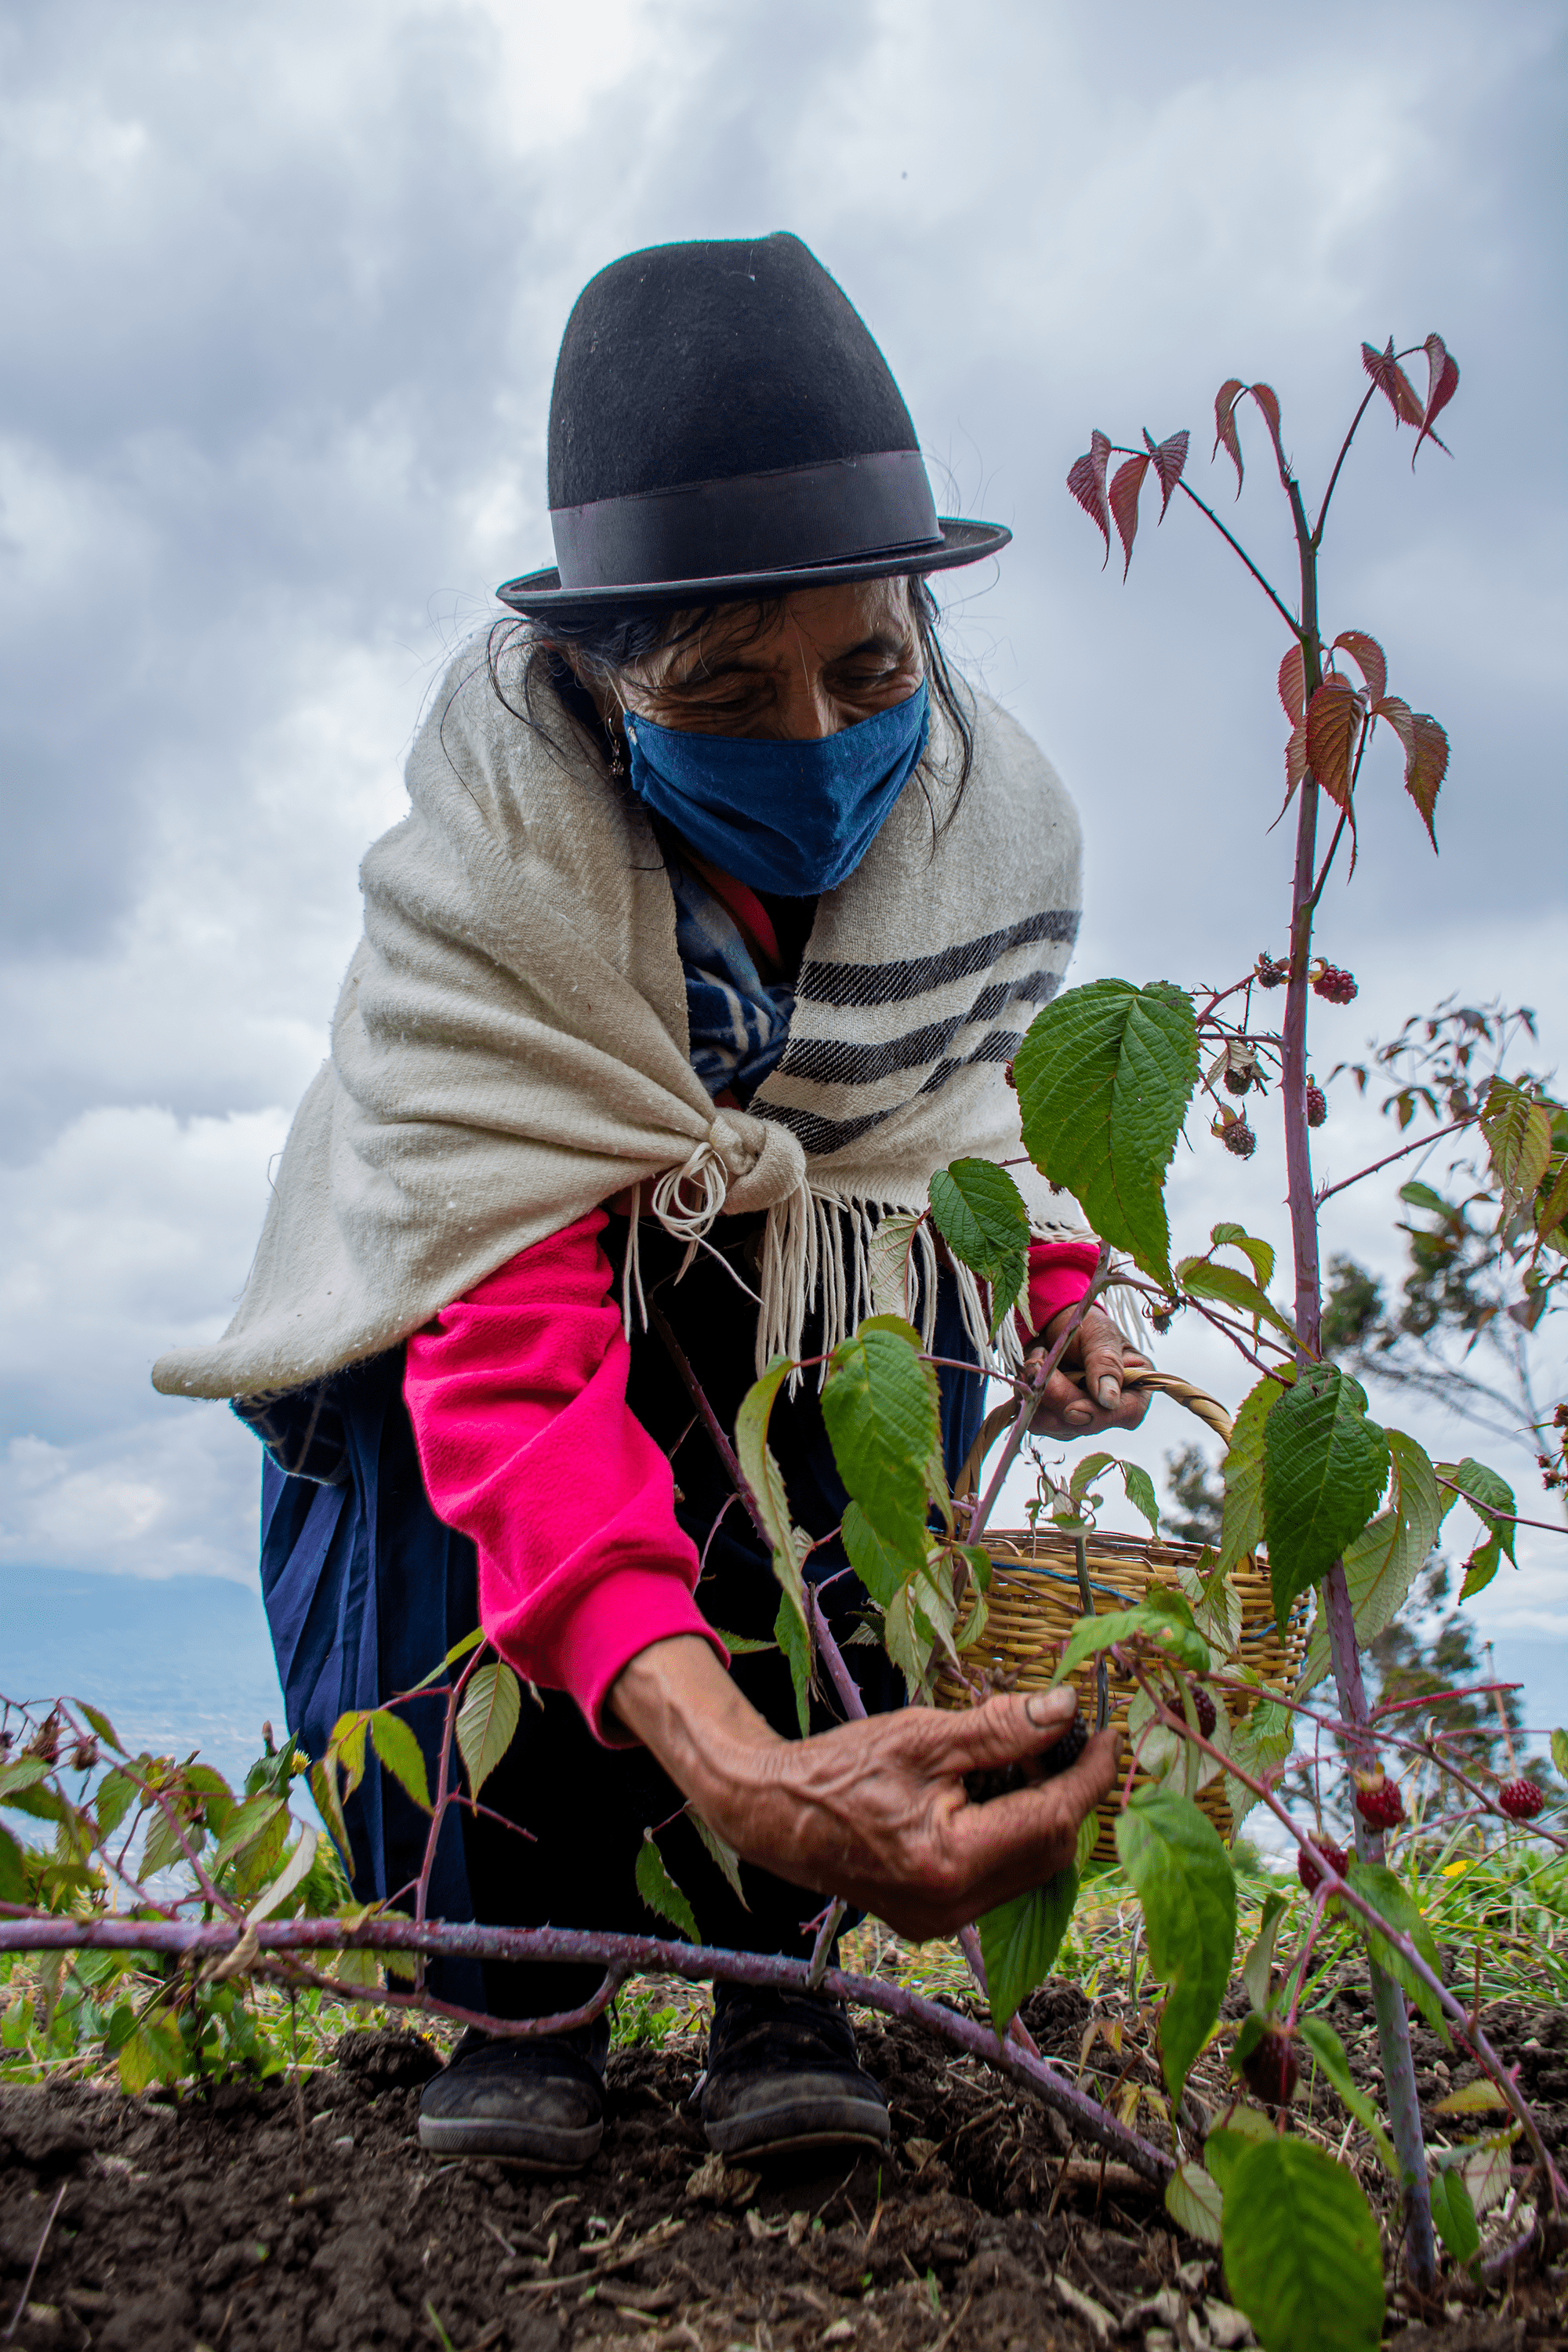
[{"left": 155, "top": 235, "right": 1140, "bottom": 2166}]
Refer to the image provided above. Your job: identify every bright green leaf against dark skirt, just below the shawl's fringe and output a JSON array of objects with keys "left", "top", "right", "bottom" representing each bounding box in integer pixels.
[{"left": 822, "top": 1315, "right": 942, "bottom": 1564}]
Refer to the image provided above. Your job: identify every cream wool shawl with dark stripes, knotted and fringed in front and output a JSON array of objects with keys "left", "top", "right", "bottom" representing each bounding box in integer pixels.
[{"left": 153, "top": 640, "right": 1083, "bottom": 1397}]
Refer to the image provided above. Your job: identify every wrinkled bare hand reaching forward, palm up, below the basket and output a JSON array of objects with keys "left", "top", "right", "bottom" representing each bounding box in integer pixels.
[{"left": 614, "top": 1635, "right": 1119, "bottom": 1943}]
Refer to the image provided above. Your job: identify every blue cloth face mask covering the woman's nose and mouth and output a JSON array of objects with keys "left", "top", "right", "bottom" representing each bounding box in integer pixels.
[{"left": 626, "top": 682, "right": 931, "bottom": 898}]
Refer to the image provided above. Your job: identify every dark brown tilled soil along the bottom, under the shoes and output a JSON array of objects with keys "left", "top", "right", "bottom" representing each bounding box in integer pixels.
[{"left": 0, "top": 1983, "right": 1568, "bottom": 2352}]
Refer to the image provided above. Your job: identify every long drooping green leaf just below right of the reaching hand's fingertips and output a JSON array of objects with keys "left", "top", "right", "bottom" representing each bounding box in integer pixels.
[{"left": 1116, "top": 1788, "right": 1236, "bottom": 2100}]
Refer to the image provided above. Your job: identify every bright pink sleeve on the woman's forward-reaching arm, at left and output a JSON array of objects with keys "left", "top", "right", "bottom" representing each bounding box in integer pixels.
[{"left": 402, "top": 1209, "right": 729, "bottom": 1740}]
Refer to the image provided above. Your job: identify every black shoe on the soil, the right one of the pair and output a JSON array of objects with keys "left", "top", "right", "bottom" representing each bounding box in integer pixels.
[{"left": 703, "top": 1985, "right": 893, "bottom": 2157}]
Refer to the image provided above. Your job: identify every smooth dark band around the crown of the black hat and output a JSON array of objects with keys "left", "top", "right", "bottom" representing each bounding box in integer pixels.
[{"left": 550, "top": 449, "right": 942, "bottom": 590}]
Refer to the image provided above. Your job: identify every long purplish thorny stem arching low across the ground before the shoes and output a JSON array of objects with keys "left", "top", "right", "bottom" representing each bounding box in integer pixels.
[{"left": 0, "top": 1919, "right": 1175, "bottom": 2190}]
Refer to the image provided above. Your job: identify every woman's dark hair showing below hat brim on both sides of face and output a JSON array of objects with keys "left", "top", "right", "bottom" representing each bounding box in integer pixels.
[{"left": 485, "top": 576, "right": 975, "bottom": 837}]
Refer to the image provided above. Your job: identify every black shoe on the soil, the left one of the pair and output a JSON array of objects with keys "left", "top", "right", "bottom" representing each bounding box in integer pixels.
[{"left": 419, "top": 2018, "right": 609, "bottom": 2173}]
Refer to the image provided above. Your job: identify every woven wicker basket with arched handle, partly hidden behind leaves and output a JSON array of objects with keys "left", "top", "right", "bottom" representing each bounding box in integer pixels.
[{"left": 935, "top": 1371, "right": 1307, "bottom": 1860}]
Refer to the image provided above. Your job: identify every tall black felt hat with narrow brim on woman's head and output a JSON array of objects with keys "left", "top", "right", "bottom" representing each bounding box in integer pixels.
[{"left": 496, "top": 235, "right": 1013, "bottom": 614}]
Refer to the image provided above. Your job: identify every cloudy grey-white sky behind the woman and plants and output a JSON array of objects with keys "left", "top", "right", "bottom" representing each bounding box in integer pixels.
[{"left": 0, "top": 0, "right": 1568, "bottom": 1731}]
